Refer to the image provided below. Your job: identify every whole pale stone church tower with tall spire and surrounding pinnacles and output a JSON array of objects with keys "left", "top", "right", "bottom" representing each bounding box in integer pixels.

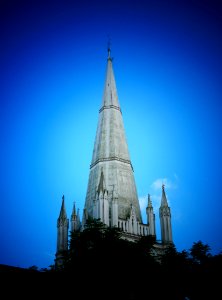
[{"left": 56, "top": 48, "right": 173, "bottom": 266}]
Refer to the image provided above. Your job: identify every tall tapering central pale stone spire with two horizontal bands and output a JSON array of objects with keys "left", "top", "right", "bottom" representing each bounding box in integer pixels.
[{"left": 85, "top": 47, "right": 142, "bottom": 222}]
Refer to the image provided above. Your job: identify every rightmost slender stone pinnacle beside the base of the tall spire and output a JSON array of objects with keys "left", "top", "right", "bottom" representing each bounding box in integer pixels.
[{"left": 159, "top": 184, "right": 173, "bottom": 244}]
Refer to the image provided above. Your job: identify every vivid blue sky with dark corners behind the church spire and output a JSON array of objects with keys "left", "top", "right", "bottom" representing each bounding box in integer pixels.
[{"left": 0, "top": 0, "right": 222, "bottom": 267}]
